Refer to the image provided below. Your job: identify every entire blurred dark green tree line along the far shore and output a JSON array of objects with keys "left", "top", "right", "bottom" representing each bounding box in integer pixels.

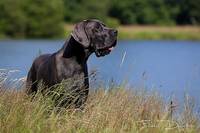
[{"left": 0, "top": 0, "right": 200, "bottom": 38}]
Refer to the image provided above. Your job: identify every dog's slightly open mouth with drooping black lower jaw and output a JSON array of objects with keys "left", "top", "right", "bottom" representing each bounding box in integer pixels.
[{"left": 95, "top": 40, "right": 117, "bottom": 57}]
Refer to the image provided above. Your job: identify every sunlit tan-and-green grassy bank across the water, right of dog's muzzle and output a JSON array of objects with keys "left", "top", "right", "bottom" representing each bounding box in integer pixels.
[{"left": 118, "top": 26, "right": 200, "bottom": 40}]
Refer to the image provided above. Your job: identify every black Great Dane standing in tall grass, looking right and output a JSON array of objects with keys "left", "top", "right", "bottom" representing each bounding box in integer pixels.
[{"left": 26, "top": 19, "right": 117, "bottom": 108}]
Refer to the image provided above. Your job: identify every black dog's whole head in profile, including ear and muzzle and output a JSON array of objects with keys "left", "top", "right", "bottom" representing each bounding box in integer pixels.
[{"left": 72, "top": 19, "right": 117, "bottom": 57}]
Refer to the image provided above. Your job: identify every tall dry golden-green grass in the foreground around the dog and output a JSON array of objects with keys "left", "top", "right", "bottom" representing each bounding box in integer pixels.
[{"left": 0, "top": 70, "right": 200, "bottom": 133}]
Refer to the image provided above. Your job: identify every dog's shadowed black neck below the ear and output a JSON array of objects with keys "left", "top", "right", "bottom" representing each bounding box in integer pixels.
[{"left": 62, "top": 36, "right": 93, "bottom": 64}]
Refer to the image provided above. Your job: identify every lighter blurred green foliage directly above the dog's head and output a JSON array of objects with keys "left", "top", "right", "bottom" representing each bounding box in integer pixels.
[{"left": 64, "top": 0, "right": 109, "bottom": 23}]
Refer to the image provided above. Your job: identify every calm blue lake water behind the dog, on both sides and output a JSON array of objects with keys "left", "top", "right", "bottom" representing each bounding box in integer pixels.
[{"left": 0, "top": 40, "right": 200, "bottom": 107}]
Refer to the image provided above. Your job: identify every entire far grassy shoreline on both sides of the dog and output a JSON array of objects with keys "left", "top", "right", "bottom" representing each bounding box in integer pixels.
[{"left": 0, "top": 24, "right": 200, "bottom": 41}]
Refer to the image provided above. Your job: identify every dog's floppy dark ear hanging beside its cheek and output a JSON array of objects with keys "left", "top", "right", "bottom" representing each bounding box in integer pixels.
[{"left": 71, "top": 20, "right": 90, "bottom": 47}]
